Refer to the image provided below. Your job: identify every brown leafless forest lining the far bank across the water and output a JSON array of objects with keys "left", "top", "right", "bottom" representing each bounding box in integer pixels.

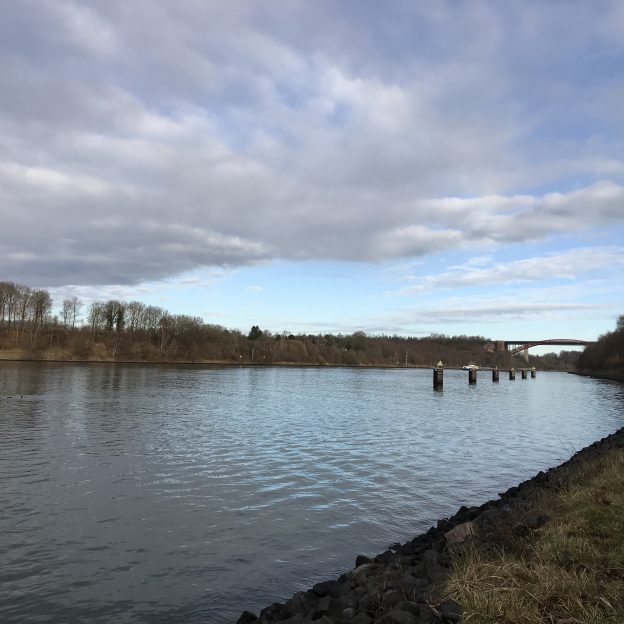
[{"left": 0, "top": 282, "right": 578, "bottom": 370}]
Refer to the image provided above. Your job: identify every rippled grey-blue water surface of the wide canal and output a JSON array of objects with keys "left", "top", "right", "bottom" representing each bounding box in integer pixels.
[{"left": 0, "top": 362, "right": 624, "bottom": 624}]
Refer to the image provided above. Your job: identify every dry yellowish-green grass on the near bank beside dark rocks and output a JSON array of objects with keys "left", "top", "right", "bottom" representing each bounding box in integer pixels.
[{"left": 448, "top": 450, "right": 624, "bottom": 624}]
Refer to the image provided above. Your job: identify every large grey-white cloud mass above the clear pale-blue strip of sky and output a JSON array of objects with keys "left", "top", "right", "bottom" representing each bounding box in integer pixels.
[{"left": 0, "top": 0, "right": 624, "bottom": 285}]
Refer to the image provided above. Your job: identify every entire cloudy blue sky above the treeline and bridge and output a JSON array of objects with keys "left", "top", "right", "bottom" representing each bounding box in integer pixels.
[{"left": 0, "top": 0, "right": 624, "bottom": 340}]
